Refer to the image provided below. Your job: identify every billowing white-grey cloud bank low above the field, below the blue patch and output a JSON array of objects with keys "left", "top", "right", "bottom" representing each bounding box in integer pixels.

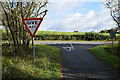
[{"left": 43, "top": 9, "right": 115, "bottom": 32}]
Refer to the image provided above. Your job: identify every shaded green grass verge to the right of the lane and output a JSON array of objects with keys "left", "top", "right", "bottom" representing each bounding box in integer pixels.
[{"left": 90, "top": 44, "right": 120, "bottom": 70}]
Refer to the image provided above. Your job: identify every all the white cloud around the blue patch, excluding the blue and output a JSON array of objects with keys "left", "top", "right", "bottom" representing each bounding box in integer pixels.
[{"left": 39, "top": 0, "right": 115, "bottom": 32}]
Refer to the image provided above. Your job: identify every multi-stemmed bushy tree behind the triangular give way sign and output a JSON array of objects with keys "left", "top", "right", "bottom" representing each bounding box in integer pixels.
[{"left": 0, "top": 0, "right": 48, "bottom": 51}]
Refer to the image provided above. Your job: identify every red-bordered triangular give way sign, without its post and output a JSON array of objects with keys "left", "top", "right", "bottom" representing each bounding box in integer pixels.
[{"left": 22, "top": 18, "right": 43, "bottom": 37}]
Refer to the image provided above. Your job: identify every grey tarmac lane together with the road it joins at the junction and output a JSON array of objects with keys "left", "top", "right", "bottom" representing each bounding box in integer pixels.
[{"left": 35, "top": 41, "right": 120, "bottom": 79}]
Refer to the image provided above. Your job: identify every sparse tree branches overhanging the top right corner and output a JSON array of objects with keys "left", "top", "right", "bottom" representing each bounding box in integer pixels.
[{"left": 104, "top": 0, "right": 120, "bottom": 28}]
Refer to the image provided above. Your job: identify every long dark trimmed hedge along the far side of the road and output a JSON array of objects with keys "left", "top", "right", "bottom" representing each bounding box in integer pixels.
[{"left": 2, "top": 32, "right": 120, "bottom": 41}]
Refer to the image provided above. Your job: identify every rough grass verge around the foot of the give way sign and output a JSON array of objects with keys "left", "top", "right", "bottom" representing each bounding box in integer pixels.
[{"left": 2, "top": 44, "right": 61, "bottom": 79}]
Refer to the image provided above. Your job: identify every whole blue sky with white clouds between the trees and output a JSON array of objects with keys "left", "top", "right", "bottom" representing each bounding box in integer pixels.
[{"left": 39, "top": 0, "right": 116, "bottom": 32}]
